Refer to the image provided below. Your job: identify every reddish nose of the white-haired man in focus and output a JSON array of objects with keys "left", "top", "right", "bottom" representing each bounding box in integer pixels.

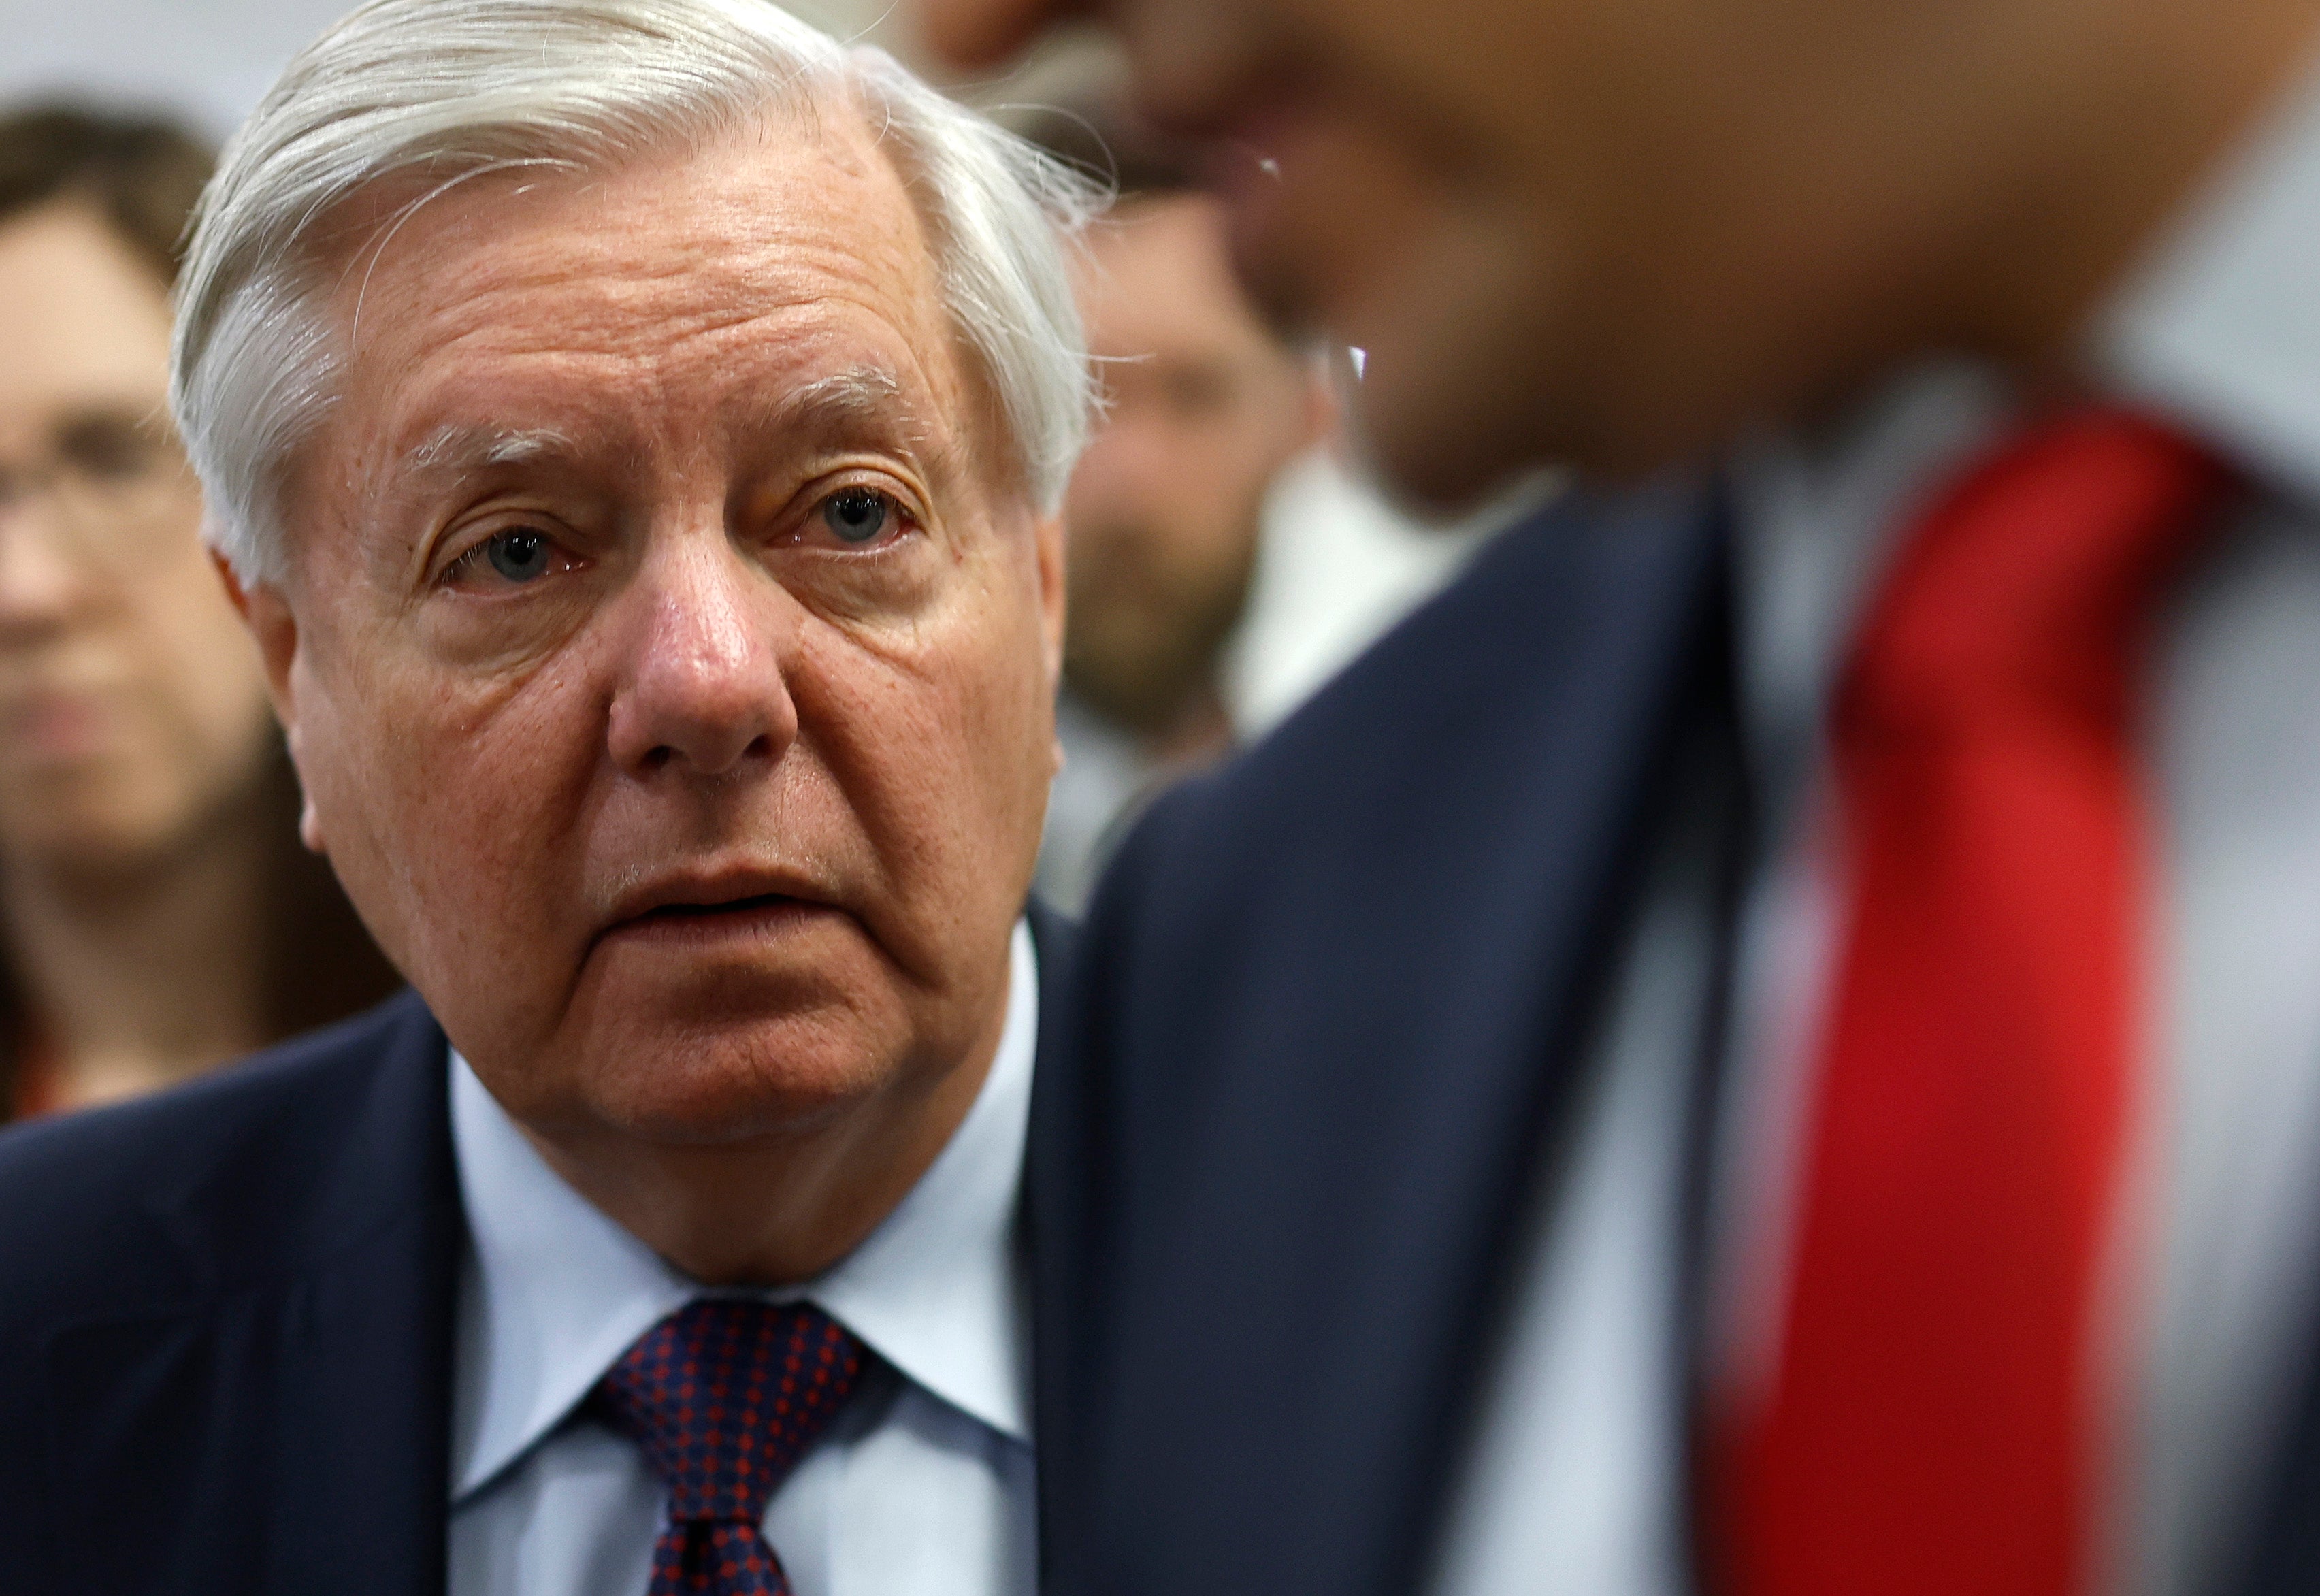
[{"left": 610, "top": 534, "right": 803, "bottom": 777}]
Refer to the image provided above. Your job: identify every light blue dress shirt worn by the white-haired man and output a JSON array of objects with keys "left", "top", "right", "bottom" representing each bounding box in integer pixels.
[{"left": 450, "top": 924, "right": 1039, "bottom": 1596}]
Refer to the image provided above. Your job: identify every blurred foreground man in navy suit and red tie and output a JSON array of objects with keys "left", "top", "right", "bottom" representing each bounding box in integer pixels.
[{"left": 926, "top": 0, "right": 2320, "bottom": 1596}]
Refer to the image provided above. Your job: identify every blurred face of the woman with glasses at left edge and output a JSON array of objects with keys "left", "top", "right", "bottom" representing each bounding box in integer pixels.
[{"left": 0, "top": 202, "right": 267, "bottom": 873}]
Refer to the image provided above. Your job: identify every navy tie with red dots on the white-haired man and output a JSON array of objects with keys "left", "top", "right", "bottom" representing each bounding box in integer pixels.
[{"left": 596, "top": 1299, "right": 868, "bottom": 1596}]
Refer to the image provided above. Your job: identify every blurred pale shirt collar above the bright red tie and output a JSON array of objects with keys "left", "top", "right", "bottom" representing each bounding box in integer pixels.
[{"left": 1731, "top": 35, "right": 2320, "bottom": 784}]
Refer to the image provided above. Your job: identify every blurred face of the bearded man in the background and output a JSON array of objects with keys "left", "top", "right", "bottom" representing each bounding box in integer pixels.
[{"left": 1062, "top": 195, "right": 1322, "bottom": 733}]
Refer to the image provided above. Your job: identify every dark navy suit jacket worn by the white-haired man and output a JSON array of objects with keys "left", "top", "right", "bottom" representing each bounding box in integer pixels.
[{"left": 0, "top": 907, "right": 1070, "bottom": 1596}]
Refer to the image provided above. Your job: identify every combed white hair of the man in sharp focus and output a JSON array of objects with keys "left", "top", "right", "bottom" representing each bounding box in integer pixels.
[{"left": 169, "top": 0, "right": 1097, "bottom": 583}]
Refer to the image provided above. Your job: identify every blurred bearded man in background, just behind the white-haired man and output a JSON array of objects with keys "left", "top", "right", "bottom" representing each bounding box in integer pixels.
[{"left": 1026, "top": 107, "right": 1332, "bottom": 914}]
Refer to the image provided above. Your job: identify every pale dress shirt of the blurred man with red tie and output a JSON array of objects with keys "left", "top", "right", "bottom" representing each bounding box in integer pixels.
[{"left": 1436, "top": 46, "right": 2320, "bottom": 1596}]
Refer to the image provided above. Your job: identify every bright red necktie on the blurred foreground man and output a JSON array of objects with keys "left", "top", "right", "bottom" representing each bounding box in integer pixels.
[{"left": 1710, "top": 410, "right": 2223, "bottom": 1596}]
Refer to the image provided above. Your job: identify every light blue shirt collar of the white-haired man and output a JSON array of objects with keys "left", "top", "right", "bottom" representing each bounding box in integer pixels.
[{"left": 450, "top": 924, "right": 1039, "bottom": 1503}]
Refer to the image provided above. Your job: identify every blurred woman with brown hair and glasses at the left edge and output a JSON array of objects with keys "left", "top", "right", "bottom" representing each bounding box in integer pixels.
[{"left": 0, "top": 109, "right": 397, "bottom": 1118}]
